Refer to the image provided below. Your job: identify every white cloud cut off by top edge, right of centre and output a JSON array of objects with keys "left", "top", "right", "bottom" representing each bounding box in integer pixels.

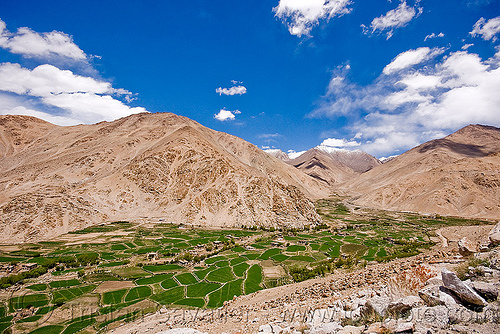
[{"left": 273, "top": 0, "right": 352, "bottom": 37}]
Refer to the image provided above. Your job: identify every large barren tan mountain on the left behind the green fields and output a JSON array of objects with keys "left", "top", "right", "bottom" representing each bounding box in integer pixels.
[{"left": 0, "top": 113, "right": 328, "bottom": 242}]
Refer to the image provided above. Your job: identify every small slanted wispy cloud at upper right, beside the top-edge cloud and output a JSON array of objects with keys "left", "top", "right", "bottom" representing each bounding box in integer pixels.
[{"left": 361, "top": 1, "right": 423, "bottom": 39}]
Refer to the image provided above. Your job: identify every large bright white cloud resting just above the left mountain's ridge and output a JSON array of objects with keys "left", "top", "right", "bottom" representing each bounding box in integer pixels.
[{"left": 0, "top": 63, "right": 146, "bottom": 125}]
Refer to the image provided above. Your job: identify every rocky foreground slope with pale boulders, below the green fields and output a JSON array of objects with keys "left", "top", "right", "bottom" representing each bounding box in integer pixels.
[{"left": 106, "top": 223, "right": 500, "bottom": 334}]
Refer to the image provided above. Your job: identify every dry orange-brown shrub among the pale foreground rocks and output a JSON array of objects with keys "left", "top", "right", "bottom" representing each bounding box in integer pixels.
[{"left": 387, "top": 265, "right": 437, "bottom": 300}]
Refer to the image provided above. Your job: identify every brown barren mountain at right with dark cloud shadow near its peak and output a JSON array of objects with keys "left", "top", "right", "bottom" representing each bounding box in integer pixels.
[{"left": 343, "top": 125, "right": 500, "bottom": 218}]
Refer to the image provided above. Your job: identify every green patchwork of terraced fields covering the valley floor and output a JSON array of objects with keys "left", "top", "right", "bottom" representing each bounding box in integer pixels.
[{"left": 0, "top": 201, "right": 492, "bottom": 334}]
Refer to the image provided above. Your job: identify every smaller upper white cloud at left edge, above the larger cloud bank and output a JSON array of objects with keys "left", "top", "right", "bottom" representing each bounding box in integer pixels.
[{"left": 0, "top": 20, "right": 86, "bottom": 61}]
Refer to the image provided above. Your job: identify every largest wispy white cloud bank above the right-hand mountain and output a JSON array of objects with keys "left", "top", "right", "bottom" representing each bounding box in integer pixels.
[{"left": 309, "top": 50, "right": 500, "bottom": 156}]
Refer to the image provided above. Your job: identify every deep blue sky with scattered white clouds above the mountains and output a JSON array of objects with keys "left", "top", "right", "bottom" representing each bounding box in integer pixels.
[{"left": 0, "top": 0, "right": 500, "bottom": 157}]
